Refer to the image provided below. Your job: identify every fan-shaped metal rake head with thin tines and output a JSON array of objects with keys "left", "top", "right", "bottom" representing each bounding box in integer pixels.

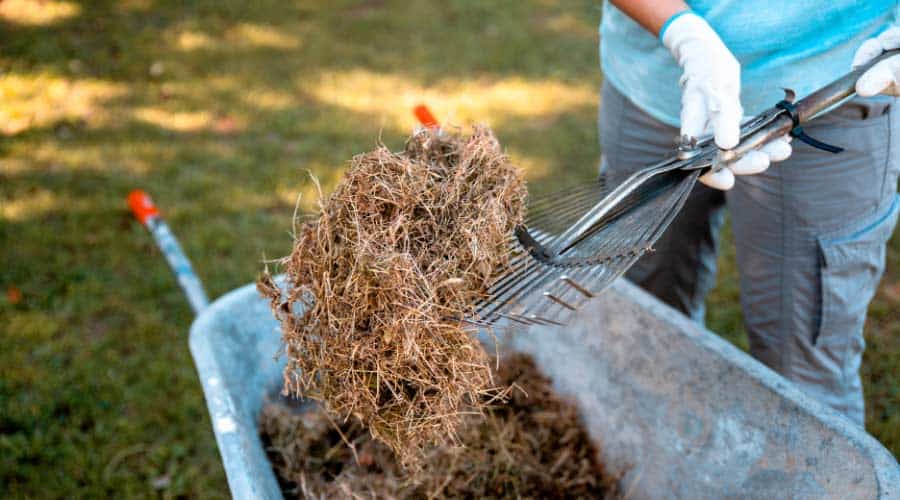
[{"left": 475, "top": 166, "right": 700, "bottom": 325}]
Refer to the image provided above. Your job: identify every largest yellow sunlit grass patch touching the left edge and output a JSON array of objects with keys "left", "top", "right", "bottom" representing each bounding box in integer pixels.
[{"left": 0, "top": 73, "right": 128, "bottom": 135}]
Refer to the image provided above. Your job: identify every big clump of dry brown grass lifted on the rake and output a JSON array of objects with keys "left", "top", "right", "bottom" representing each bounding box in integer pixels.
[{"left": 259, "top": 127, "right": 526, "bottom": 466}]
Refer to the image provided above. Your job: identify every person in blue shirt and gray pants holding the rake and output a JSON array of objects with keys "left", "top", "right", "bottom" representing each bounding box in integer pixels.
[{"left": 599, "top": 0, "right": 900, "bottom": 425}]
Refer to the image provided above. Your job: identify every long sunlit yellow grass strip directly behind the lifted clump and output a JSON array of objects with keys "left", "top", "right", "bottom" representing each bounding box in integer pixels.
[{"left": 297, "top": 69, "right": 597, "bottom": 130}]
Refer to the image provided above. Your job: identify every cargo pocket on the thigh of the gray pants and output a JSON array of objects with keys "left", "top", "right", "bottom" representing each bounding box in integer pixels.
[{"left": 813, "top": 195, "right": 900, "bottom": 364}]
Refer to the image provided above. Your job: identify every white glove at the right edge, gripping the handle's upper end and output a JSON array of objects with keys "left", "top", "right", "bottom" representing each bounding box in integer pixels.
[{"left": 853, "top": 26, "right": 900, "bottom": 97}]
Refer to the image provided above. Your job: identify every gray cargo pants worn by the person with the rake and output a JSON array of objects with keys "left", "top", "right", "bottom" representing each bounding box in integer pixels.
[{"left": 600, "top": 83, "right": 900, "bottom": 425}]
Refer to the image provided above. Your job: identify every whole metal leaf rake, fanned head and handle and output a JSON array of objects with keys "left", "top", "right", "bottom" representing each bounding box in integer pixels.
[{"left": 472, "top": 50, "right": 900, "bottom": 326}]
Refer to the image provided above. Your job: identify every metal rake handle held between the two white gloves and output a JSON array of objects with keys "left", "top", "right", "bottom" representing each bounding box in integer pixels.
[{"left": 731, "top": 49, "right": 900, "bottom": 158}]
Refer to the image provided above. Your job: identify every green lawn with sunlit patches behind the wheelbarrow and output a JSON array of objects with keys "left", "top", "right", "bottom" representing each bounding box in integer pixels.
[{"left": 0, "top": 0, "right": 900, "bottom": 497}]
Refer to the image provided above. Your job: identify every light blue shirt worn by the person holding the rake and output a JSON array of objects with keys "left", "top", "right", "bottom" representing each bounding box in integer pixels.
[{"left": 600, "top": 0, "right": 900, "bottom": 126}]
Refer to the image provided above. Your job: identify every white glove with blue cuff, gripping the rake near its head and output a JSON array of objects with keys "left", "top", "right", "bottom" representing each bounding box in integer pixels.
[{"left": 662, "top": 12, "right": 791, "bottom": 190}]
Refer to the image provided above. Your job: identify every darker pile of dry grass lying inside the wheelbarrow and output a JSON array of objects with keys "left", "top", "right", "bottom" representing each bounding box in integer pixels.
[{"left": 260, "top": 355, "right": 616, "bottom": 498}]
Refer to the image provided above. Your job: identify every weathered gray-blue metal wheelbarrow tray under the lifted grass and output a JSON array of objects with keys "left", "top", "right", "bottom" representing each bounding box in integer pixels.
[{"left": 190, "top": 280, "right": 900, "bottom": 500}]
